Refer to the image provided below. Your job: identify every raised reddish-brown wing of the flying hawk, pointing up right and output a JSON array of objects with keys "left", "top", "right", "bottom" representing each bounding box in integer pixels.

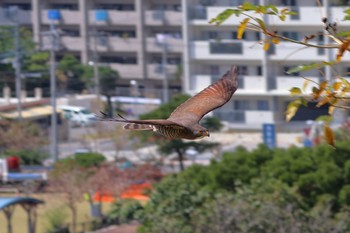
[{"left": 168, "top": 66, "right": 238, "bottom": 126}]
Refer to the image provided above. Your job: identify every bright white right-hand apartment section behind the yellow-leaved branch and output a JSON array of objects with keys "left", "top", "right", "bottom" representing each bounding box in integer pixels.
[{"left": 182, "top": 0, "right": 350, "bottom": 128}]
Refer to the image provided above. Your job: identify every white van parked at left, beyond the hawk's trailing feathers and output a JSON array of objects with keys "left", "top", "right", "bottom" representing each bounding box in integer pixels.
[{"left": 58, "top": 105, "right": 96, "bottom": 125}]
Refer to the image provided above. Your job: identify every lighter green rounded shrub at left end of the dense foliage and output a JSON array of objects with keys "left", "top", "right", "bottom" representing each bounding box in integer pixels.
[{"left": 140, "top": 175, "right": 209, "bottom": 233}]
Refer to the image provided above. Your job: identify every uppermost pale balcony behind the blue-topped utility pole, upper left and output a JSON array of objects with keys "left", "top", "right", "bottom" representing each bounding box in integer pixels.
[{"left": 41, "top": 9, "right": 82, "bottom": 25}]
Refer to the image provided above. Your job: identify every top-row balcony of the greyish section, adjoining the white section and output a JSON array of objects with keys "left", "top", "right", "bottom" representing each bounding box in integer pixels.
[{"left": 145, "top": 10, "right": 183, "bottom": 26}]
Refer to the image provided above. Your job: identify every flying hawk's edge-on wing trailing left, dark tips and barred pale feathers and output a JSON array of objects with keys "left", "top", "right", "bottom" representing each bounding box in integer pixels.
[{"left": 96, "top": 112, "right": 182, "bottom": 131}]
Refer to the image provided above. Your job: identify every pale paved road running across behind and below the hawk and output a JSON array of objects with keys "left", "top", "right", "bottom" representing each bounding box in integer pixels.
[{"left": 59, "top": 124, "right": 301, "bottom": 170}]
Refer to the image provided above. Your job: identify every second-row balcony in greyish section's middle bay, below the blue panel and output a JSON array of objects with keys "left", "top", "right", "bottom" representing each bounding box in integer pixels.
[{"left": 91, "top": 36, "right": 141, "bottom": 52}]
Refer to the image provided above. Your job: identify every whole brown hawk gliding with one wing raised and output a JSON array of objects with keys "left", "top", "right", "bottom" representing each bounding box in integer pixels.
[{"left": 99, "top": 66, "right": 238, "bottom": 140}]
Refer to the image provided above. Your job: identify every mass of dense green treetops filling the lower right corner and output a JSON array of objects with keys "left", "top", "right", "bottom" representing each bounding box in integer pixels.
[{"left": 112, "top": 141, "right": 350, "bottom": 233}]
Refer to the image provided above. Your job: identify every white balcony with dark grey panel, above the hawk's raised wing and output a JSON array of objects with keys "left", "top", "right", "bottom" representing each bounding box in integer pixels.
[{"left": 190, "top": 40, "right": 264, "bottom": 61}]
